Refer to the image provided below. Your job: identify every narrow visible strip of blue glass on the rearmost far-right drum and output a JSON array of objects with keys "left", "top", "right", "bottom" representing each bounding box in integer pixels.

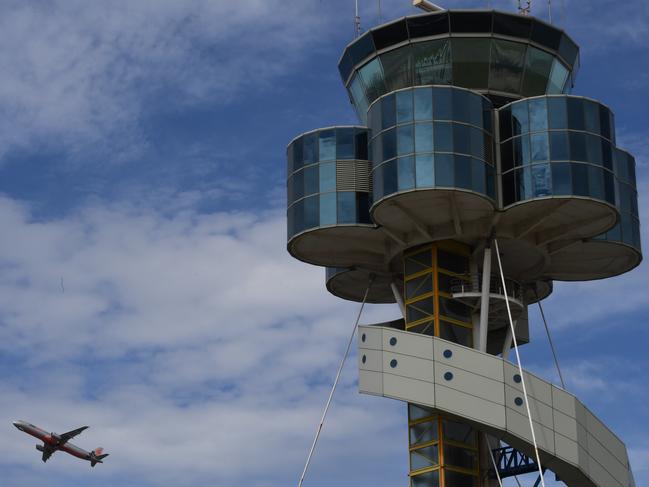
[{"left": 594, "top": 149, "right": 642, "bottom": 253}]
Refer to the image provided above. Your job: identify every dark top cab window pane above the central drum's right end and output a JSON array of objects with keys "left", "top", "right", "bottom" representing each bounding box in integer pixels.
[{"left": 451, "top": 38, "right": 491, "bottom": 89}]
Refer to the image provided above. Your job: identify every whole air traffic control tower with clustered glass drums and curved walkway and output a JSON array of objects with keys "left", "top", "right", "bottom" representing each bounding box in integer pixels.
[{"left": 287, "top": 4, "right": 642, "bottom": 487}]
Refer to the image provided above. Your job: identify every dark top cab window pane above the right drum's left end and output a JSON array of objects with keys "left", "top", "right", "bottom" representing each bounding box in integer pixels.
[{"left": 489, "top": 39, "right": 526, "bottom": 93}]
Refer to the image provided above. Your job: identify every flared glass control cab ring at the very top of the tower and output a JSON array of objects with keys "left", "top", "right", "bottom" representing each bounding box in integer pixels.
[{"left": 339, "top": 11, "right": 579, "bottom": 121}]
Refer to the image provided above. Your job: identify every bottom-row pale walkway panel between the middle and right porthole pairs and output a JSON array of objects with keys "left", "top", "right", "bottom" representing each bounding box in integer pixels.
[{"left": 435, "top": 384, "right": 506, "bottom": 429}]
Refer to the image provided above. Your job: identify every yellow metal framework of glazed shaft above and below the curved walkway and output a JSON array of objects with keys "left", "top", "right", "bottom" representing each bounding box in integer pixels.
[{"left": 403, "top": 241, "right": 480, "bottom": 487}]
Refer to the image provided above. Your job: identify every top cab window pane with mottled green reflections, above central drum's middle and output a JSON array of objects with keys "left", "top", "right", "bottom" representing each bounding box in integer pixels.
[{"left": 412, "top": 39, "right": 452, "bottom": 85}]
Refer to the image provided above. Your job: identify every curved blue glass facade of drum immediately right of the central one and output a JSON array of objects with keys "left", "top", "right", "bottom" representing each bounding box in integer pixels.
[{"left": 499, "top": 96, "right": 616, "bottom": 207}]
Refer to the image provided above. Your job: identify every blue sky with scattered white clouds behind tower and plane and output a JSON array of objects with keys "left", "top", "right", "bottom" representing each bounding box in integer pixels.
[{"left": 0, "top": 0, "right": 649, "bottom": 487}]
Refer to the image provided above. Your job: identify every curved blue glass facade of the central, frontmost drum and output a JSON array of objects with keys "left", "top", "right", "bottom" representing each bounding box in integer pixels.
[{"left": 368, "top": 86, "right": 495, "bottom": 202}]
